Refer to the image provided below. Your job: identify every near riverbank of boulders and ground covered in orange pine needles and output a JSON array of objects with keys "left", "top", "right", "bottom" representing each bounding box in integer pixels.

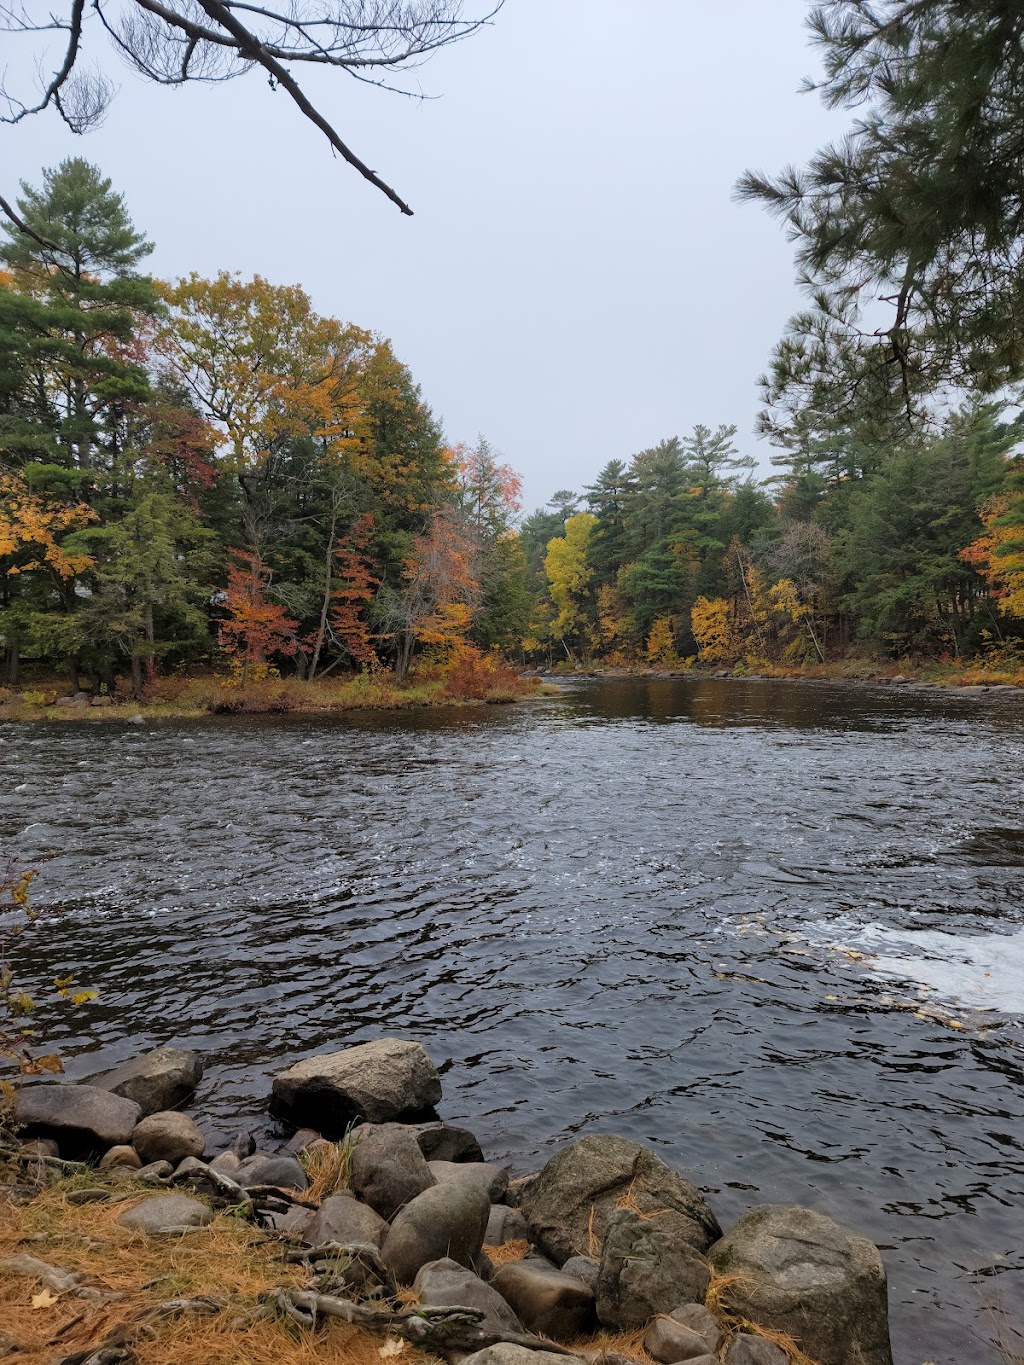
[{"left": 0, "top": 1039, "right": 892, "bottom": 1365}]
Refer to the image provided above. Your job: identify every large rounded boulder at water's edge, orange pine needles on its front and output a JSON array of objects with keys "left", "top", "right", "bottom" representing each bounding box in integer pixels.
[{"left": 522, "top": 1136, "right": 721, "bottom": 1261}]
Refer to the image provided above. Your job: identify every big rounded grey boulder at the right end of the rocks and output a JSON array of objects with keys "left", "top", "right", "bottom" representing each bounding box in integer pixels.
[{"left": 710, "top": 1204, "right": 893, "bottom": 1365}]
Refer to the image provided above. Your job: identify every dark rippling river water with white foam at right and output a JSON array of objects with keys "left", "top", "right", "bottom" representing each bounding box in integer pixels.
[{"left": 0, "top": 680, "right": 1024, "bottom": 1365}]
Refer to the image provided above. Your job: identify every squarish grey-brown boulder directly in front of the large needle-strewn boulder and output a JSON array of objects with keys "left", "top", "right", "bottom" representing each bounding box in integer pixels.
[{"left": 597, "top": 1208, "right": 711, "bottom": 1328}]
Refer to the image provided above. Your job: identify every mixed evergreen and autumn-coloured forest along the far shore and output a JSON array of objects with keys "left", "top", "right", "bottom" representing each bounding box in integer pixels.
[{"left": 0, "top": 158, "right": 1024, "bottom": 708}]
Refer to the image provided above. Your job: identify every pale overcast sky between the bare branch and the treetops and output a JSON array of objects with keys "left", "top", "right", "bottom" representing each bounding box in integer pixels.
[{"left": 0, "top": 0, "right": 847, "bottom": 508}]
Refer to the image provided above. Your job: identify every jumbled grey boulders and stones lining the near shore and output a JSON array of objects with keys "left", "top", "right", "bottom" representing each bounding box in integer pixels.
[{"left": 0, "top": 1039, "right": 892, "bottom": 1365}]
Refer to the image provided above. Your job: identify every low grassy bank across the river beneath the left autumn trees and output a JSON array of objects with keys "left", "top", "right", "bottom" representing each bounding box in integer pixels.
[{"left": 0, "top": 667, "right": 558, "bottom": 723}]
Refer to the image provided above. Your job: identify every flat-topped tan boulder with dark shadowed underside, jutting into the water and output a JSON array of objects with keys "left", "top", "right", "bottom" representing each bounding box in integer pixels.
[{"left": 270, "top": 1039, "right": 441, "bottom": 1137}]
